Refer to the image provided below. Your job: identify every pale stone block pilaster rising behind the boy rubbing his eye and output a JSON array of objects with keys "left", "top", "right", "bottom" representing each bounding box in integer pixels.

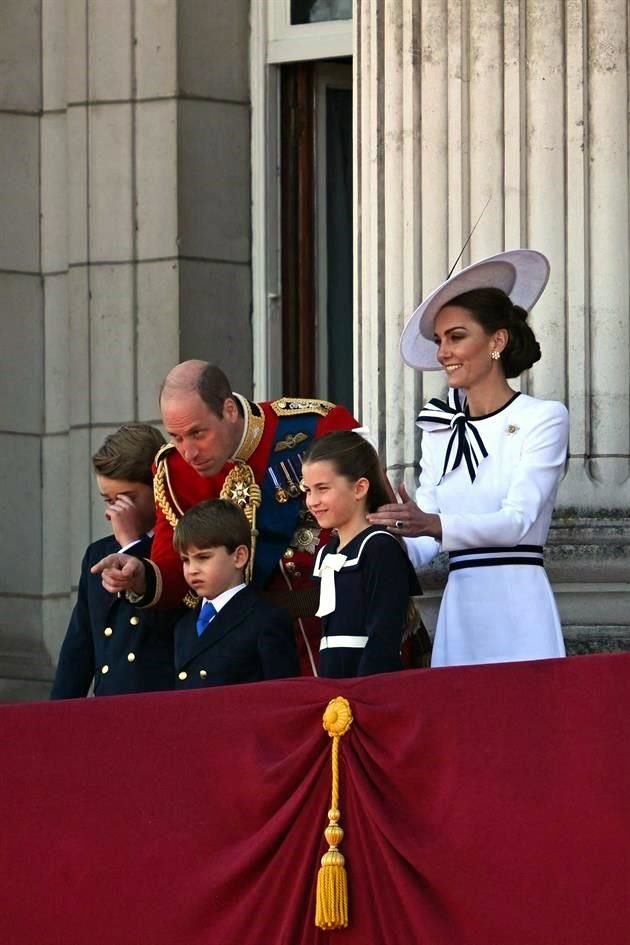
[{"left": 64, "top": 0, "right": 179, "bottom": 668}]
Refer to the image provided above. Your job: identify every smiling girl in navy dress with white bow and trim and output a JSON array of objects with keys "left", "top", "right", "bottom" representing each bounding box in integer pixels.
[{"left": 302, "top": 430, "right": 421, "bottom": 678}]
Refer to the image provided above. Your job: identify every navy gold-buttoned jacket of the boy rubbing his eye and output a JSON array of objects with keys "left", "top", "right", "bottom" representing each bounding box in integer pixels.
[{"left": 51, "top": 535, "right": 182, "bottom": 699}]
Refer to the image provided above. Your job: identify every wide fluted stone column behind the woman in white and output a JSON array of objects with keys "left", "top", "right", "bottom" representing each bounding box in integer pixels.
[{"left": 354, "top": 0, "right": 630, "bottom": 648}]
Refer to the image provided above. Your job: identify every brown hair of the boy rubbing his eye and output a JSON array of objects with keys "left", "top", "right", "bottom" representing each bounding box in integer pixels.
[{"left": 92, "top": 423, "right": 165, "bottom": 486}]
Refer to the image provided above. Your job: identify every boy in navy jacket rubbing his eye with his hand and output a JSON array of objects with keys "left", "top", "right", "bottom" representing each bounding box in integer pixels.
[{"left": 51, "top": 423, "right": 181, "bottom": 699}]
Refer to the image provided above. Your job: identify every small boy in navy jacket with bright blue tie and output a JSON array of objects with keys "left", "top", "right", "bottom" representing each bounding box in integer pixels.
[{"left": 173, "top": 499, "right": 299, "bottom": 689}]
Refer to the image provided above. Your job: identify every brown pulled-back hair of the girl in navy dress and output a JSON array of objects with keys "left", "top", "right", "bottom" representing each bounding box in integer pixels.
[{"left": 302, "top": 430, "right": 393, "bottom": 512}]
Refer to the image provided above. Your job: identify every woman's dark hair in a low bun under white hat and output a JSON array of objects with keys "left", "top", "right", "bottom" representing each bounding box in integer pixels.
[{"left": 447, "top": 289, "right": 540, "bottom": 377}]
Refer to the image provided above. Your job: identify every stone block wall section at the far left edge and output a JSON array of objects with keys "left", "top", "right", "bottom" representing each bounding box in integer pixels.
[{"left": 0, "top": 0, "right": 69, "bottom": 699}]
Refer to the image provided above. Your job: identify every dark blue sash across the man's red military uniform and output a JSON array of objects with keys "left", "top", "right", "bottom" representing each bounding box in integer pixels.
[{"left": 252, "top": 413, "right": 320, "bottom": 588}]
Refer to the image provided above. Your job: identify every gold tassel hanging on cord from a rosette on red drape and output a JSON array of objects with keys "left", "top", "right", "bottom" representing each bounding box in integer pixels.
[{"left": 315, "top": 696, "right": 352, "bottom": 929}]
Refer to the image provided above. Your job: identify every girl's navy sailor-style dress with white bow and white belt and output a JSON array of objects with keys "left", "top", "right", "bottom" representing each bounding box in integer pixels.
[{"left": 313, "top": 525, "right": 421, "bottom": 678}]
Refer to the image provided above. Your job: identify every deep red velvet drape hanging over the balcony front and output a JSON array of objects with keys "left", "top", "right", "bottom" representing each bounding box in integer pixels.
[{"left": 0, "top": 655, "right": 630, "bottom": 945}]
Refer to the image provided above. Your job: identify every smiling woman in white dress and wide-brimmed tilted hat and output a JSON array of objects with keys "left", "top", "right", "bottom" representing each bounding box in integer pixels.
[{"left": 370, "top": 250, "right": 569, "bottom": 666}]
